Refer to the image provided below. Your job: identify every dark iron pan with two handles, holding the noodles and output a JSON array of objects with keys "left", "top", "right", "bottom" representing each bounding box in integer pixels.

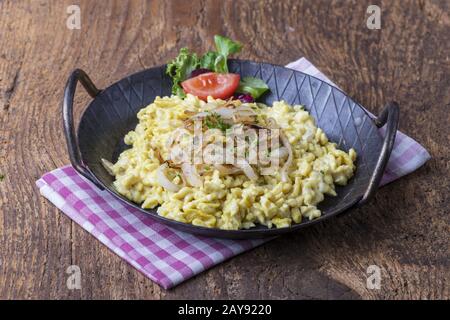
[{"left": 62, "top": 60, "right": 399, "bottom": 239}]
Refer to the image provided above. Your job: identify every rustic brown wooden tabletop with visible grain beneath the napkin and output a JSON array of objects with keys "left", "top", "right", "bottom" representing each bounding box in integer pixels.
[{"left": 0, "top": 0, "right": 450, "bottom": 299}]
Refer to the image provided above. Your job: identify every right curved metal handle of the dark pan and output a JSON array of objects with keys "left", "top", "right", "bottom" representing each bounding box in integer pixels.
[{"left": 358, "top": 101, "right": 399, "bottom": 206}]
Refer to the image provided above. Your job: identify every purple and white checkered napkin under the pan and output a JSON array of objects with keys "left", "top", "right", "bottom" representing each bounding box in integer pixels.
[{"left": 36, "top": 58, "right": 430, "bottom": 289}]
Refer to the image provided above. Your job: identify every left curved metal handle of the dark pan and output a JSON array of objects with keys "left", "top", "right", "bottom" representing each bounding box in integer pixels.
[{"left": 62, "top": 69, "right": 104, "bottom": 190}]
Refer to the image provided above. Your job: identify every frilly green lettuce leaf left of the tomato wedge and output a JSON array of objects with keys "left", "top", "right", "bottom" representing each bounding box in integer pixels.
[{"left": 166, "top": 48, "right": 200, "bottom": 97}]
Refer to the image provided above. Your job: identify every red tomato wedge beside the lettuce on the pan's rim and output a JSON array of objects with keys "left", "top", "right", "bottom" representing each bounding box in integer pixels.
[{"left": 181, "top": 72, "right": 241, "bottom": 101}]
